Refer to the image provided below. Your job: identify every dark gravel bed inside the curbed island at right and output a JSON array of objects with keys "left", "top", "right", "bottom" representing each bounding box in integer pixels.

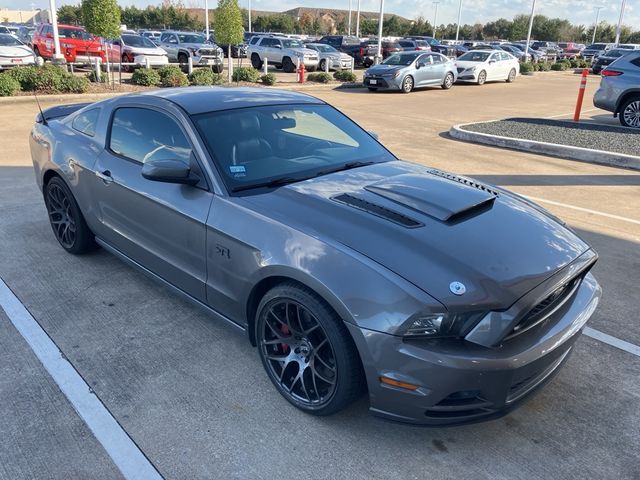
[{"left": 460, "top": 118, "right": 640, "bottom": 156}]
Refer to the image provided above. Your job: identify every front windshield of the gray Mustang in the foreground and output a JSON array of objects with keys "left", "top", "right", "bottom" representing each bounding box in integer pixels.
[{"left": 194, "top": 105, "right": 395, "bottom": 191}]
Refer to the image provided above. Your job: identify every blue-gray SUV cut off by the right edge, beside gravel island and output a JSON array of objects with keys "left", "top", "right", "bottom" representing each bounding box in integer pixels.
[{"left": 593, "top": 51, "right": 640, "bottom": 128}]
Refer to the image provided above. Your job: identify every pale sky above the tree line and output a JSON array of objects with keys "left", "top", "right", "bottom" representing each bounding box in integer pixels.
[{"left": 7, "top": 0, "right": 640, "bottom": 29}]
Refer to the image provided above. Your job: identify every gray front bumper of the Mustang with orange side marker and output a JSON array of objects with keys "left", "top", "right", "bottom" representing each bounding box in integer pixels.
[{"left": 347, "top": 274, "right": 601, "bottom": 425}]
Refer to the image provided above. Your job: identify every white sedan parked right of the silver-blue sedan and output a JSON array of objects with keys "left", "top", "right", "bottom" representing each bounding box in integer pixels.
[{"left": 456, "top": 50, "right": 520, "bottom": 85}]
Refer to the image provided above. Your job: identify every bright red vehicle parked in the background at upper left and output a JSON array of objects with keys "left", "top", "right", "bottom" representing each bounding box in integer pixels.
[{"left": 31, "top": 23, "right": 106, "bottom": 63}]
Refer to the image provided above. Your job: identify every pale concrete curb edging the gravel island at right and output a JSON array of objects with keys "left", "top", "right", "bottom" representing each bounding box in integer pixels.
[{"left": 449, "top": 120, "right": 640, "bottom": 170}]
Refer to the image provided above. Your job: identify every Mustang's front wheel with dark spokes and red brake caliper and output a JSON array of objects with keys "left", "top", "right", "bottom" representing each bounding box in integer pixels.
[{"left": 256, "top": 283, "right": 364, "bottom": 415}]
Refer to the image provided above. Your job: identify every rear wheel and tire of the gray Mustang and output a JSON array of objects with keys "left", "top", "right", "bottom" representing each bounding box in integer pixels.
[{"left": 44, "top": 177, "right": 96, "bottom": 255}]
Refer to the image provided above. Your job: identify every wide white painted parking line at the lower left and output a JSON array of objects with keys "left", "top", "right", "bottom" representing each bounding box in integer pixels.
[{"left": 0, "top": 279, "right": 162, "bottom": 480}]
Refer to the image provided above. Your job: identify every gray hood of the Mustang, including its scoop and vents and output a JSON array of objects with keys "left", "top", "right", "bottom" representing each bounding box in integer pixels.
[{"left": 243, "top": 161, "right": 589, "bottom": 310}]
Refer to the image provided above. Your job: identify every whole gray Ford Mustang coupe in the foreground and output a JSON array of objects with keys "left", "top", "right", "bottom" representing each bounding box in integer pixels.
[{"left": 30, "top": 87, "right": 600, "bottom": 425}]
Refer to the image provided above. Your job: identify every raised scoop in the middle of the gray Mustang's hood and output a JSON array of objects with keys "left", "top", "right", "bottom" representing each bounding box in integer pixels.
[{"left": 364, "top": 173, "right": 498, "bottom": 222}]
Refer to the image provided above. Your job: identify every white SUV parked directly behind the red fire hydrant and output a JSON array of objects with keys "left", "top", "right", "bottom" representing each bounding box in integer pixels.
[{"left": 247, "top": 35, "right": 318, "bottom": 73}]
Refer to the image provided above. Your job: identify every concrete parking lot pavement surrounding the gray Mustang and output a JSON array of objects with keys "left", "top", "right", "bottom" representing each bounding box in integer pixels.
[{"left": 0, "top": 74, "right": 640, "bottom": 479}]
